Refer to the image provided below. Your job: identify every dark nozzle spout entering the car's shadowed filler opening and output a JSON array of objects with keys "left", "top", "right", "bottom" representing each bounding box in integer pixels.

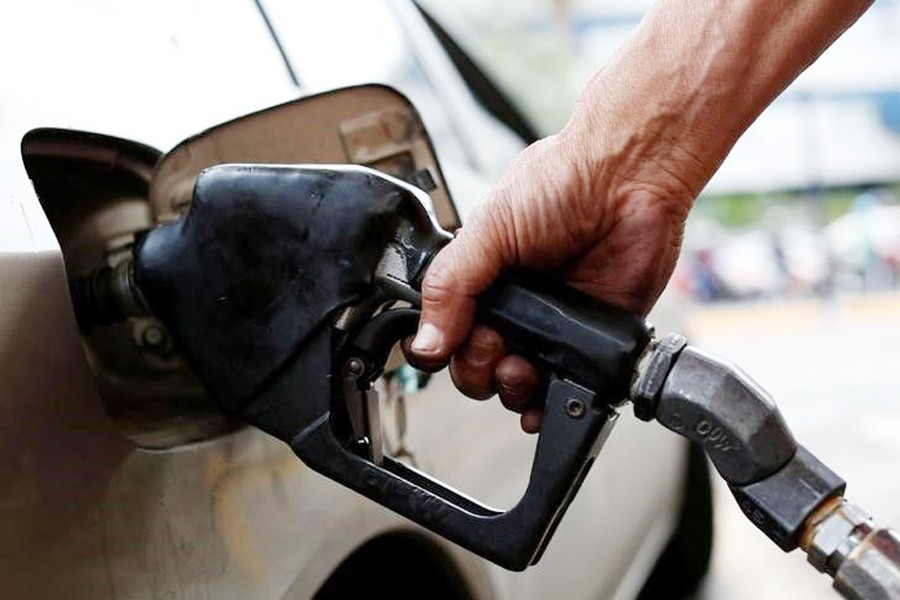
[{"left": 69, "top": 257, "right": 150, "bottom": 333}]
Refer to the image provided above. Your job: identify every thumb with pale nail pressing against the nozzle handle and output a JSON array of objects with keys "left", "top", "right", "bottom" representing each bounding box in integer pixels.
[{"left": 410, "top": 218, "right": 506, "bottom": 364}]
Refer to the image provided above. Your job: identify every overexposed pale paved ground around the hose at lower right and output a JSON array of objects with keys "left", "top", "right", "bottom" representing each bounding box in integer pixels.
[{"left": 689, "top": 294, "right": 900, "bottom": 600}]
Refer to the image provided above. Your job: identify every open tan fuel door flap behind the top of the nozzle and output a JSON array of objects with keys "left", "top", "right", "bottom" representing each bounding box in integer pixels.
[{"left": 150, "top": 85, "right": 459, "bottom": 231}]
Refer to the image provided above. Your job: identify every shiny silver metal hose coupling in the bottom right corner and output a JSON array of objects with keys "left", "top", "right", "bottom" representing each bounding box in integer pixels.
[{"left": 800, "top": 498, "right": 900, "bottom": 600}]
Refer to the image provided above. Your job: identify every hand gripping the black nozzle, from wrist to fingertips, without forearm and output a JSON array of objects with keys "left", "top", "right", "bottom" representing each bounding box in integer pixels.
[{"left": 408, "top": 113, "right": 693, "bottom": 432}]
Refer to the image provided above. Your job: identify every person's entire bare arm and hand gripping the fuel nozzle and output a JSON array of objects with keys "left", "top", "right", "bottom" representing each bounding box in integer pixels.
[{"left": 407, "top": 0, "right": 871, "bottom": 431}]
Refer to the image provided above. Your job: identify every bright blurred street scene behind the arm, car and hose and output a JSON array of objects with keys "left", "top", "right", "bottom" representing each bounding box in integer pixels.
[{"left": 423, "top": 0, "right": 900, "bottom": 599}]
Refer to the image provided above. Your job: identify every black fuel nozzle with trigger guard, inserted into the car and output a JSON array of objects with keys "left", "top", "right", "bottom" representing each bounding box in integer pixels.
[{"left": 70, "top": 165, "right": 651, "bottom": 570}]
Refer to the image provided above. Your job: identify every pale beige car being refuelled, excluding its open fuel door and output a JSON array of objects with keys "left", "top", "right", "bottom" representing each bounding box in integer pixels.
[{"left": 0, "top": 0, "right": 711, "bottom": 600}]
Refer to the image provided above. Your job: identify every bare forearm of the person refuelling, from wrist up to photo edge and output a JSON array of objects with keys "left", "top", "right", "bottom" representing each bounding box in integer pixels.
[{"left": 564, "top": 0, "right": 871, "bottom": 206}]
